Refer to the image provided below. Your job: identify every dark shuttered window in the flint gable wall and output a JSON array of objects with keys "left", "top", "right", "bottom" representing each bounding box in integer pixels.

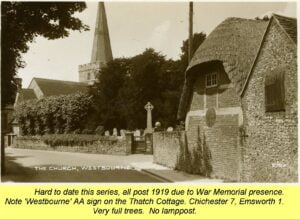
[{"left": 265, "top": 68, "right": 285, "bottom": 112}]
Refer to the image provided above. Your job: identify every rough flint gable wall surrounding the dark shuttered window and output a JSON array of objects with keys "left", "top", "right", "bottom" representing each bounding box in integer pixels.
[{"left": 241, "top": 20, "right": 298, "bottom": 182}]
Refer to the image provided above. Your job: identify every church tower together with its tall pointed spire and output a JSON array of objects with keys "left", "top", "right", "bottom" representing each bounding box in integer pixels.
[{"left": 79, "top": 2, "right": 113, "bottom": 84}]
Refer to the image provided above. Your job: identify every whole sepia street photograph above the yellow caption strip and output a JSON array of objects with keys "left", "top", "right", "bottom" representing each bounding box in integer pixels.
[{"left": 1, "top": 1, "right": 298, "bottom": 184}]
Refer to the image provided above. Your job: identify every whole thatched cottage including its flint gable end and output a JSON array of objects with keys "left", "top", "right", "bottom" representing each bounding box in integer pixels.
[{"left": 178, "top": 14, "right": 298, "bottom": 182}]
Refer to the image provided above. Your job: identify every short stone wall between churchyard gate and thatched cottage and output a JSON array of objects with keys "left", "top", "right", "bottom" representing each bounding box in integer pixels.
[{"left": 153, "top": 131, "right": 185, "bottom": 168}]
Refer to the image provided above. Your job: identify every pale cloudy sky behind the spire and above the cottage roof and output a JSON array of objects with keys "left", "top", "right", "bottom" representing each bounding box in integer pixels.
[{"left": 19, "top": 2, "right": 297, "bottom": 87}]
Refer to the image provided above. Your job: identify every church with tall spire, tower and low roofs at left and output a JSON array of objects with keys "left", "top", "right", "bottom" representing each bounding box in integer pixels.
[{"left": 15, "top": 2, "right": 113, "bottom": 108}]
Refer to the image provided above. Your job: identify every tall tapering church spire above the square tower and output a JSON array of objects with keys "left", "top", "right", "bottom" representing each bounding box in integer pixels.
[{"left": 91, "top": 2, "right": 112, "bottom": 63}]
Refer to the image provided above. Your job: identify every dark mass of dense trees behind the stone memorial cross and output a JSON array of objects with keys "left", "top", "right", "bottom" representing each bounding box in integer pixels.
[{"left": 90, "top": 33, "right": 206, "bottom": 130}]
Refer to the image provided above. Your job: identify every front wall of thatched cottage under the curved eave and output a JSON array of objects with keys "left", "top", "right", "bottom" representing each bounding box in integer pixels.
[{"left": 186, "top": 66, "right": 243, "bottom": 181}]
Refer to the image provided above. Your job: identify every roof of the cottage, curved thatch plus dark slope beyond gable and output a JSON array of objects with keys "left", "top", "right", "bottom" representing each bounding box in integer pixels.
[{"left": 177, "top": 15, "right": 297, "bottom": 119}]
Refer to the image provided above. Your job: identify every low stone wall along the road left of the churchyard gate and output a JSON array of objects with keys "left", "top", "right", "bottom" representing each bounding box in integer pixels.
[{"left": 12, "top": 136, "right": 132, "bottom": 155}]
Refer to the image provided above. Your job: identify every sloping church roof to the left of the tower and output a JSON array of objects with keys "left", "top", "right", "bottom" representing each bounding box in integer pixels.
[{"left": 32, "top": 78, "right": 88, "bottom": 97}]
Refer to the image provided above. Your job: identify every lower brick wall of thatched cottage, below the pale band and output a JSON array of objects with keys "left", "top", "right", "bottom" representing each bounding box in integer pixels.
[{"left": 187, "top": 114, "right": 241, "bottom": 181}]
